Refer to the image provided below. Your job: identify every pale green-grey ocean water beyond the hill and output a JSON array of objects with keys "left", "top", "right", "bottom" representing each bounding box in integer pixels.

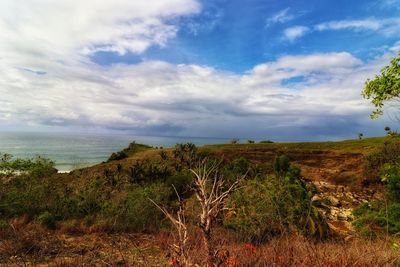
[{"left": 0, "top": 132, "right": 229, "bottom": 172}]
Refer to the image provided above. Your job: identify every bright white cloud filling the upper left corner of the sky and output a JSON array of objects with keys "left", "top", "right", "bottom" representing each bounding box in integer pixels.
[{"left": 0, "top": 0, "right": 200, "bottom": 57}]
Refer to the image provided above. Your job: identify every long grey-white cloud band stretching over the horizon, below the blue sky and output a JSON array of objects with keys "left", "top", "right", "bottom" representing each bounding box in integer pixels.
[{"left": 0, "top": 45, "right": 394, "bottom": 139}]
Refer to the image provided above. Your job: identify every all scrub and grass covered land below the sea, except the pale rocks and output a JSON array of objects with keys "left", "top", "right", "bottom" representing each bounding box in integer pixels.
[{"left": 0, "top": 136, "right": 400, "bottom": 266}]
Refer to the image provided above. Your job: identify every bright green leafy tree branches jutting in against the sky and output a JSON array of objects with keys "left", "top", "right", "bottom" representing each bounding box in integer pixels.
[{"left": 362, "top": 54, "right": 400, "bottom": 119}]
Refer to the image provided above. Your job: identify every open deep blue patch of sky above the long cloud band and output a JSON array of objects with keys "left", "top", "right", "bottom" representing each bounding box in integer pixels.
[{"left": 92, "top": 0, "right": 400, "bottom": 73}]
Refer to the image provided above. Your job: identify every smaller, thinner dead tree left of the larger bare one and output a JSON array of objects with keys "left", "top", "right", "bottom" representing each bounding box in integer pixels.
[{"left": 149, "top": 186, "right": 191, "bottom": 266}]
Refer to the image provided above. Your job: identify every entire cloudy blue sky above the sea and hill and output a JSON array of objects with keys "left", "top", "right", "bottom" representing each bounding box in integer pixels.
[{"left": 0, "top": 0, "right": 400, "bottom": 141}]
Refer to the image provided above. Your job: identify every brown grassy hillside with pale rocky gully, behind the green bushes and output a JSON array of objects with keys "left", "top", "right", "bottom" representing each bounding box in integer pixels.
[{"left": 70, "top": 137, "right": 391, "bottom": 237}]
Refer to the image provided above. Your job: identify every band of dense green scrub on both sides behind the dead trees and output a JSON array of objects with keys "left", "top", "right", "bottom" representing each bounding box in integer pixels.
[{"left": 0, "top": 147, "right": 327, "bottom": 242}]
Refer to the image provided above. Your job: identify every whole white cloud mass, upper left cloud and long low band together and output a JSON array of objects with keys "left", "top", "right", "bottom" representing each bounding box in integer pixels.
[{"left": 0, "top": 0, "right": 396, "bottom": 140}]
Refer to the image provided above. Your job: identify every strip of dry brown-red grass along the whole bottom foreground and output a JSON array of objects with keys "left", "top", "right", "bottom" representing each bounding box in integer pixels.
[{"left": 0, "top": 225, "right": 400, "bottom": 267}]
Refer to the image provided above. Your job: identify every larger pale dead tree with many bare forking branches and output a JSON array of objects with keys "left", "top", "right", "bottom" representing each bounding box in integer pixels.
[{"left": 190, "top": 159, "right": 247, "bottom": 267}]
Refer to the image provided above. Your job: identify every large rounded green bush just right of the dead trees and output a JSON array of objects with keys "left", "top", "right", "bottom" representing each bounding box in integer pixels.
[{"left": 224, "top": 156, "right": 329, "bottom": 243}]
